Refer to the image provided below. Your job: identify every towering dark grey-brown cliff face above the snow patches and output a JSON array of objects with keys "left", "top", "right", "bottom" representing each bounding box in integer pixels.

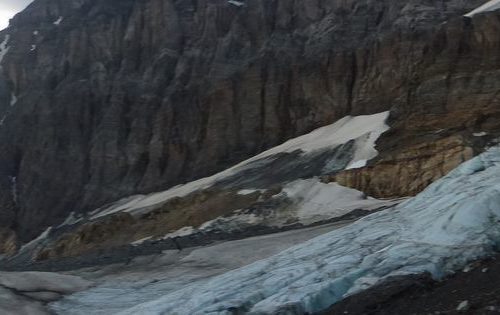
[{"left": 0, "top": 0, "right": 500, "bottom": 241}]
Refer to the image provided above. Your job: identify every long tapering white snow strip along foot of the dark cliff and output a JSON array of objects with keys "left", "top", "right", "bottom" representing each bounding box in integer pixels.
[{"left": 91, "top": 112, "right": 389, "bottom": 219}]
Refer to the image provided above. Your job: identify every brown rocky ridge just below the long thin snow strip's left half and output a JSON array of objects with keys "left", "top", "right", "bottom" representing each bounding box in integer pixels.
[{"left": 33, "top": 190, "right": 264, "bottom": 261}]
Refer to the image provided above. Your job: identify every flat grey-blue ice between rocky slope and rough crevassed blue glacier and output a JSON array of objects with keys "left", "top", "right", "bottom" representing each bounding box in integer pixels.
[{"left": 52, "top": 223, "right": 345, "bottom": 315}]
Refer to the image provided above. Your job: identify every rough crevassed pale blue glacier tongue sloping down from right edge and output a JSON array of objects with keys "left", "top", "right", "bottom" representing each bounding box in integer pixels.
[{"left": 112, "top": 147, "right": 500, "bottom": 314}]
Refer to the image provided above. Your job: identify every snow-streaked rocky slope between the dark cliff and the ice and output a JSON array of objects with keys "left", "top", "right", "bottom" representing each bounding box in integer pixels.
[{"left": 0, "top": 112, "right": 399, "bottom": 270}]
